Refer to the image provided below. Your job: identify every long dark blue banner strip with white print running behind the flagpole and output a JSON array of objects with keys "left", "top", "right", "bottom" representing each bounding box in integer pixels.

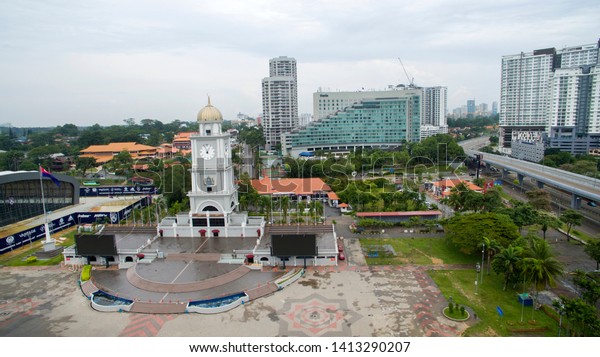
[{"left": 0, "top": 196, "right": 152, "bottom": 254}]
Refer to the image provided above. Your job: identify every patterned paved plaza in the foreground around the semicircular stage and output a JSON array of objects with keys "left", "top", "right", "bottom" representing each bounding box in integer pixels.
[{"left": 0, "top": 260, "right": 467, "bottom": 337}]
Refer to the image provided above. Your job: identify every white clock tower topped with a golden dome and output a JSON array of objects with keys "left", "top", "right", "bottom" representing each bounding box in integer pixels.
[{"left": 188, "top": 98, "right": 238, "bottom": 231}]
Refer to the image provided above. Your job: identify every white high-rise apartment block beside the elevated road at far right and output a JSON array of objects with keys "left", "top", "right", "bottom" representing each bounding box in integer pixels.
[{"left": 500, "top": 43, "right": 600, "bottom": 153}]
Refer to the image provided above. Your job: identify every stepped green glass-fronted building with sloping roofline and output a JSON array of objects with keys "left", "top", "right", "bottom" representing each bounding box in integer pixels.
[{"left": 282, "top": 94, "right": 422, "bottom": 157}]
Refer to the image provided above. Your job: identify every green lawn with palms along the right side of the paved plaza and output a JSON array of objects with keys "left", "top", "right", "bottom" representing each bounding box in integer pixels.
[{"left": 360, "top": 238, "right": 558, "bottom": 337}]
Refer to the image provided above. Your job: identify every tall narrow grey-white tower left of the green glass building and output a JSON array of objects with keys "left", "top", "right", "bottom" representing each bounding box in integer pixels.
[{"left": 261, "top": 56, "right": 299, "bottom": 148}]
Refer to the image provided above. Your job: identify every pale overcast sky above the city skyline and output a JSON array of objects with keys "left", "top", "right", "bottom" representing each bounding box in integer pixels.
[{"left": 0, "top": 0, "right": 600, "bottom": 127}]
